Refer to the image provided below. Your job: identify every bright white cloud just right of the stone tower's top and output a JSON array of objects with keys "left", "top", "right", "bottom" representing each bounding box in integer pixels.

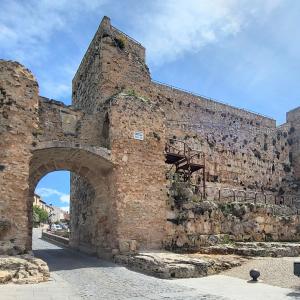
[{"left": 136, "top": 0, "right": 282, "bottom": 65}]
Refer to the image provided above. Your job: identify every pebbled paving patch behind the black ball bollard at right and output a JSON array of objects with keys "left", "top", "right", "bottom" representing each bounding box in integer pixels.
[{"left": 222, "top": 257, "right": 300, "bottom": 290}]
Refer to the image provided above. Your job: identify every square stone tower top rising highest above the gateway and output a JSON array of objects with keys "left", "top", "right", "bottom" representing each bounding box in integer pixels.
[{"left": 72, "top": 17, "right": 150, "bottom": 112}]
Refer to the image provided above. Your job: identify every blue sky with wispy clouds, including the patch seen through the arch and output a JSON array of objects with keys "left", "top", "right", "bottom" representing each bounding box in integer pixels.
[{"left": 0, "top": 0, "right": 300, "bottom": 211}]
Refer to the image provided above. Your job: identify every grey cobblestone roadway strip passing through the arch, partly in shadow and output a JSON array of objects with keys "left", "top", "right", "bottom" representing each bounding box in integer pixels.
[{"left": 33, "top": 233, "right": 228, "bottom": 300}]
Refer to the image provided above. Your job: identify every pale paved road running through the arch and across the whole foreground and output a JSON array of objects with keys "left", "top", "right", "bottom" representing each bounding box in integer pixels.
[{"left": 0, "top": 232, "right": 300, "bottom": 300}]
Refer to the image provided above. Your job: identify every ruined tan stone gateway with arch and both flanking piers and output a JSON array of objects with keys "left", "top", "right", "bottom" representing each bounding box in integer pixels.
[{"left": 0, "top": 56, "right": 166, "bottom": 256}]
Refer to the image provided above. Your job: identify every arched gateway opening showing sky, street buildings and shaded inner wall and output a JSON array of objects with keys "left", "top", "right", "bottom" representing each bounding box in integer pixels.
[{"left": 32, "top": 170, "right": 97, "bottom": 252}]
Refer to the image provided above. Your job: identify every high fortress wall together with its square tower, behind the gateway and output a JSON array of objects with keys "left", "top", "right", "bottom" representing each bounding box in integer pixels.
[{"left": 73, "top": 18, "right": 299, "bottom": 202}]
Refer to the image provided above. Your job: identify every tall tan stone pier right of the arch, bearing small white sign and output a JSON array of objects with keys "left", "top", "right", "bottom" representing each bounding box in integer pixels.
[{"left": 109, "top": 94, "right": 167, "bottom": 251}]
